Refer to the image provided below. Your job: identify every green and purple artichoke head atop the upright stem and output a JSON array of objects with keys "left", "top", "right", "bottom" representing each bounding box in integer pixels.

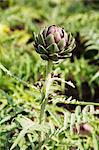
[{"left": 34, "top": 25, "right": 75, "bottom": 61}]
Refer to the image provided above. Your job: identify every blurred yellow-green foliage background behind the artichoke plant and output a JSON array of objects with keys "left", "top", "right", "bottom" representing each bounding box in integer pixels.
[{"left": 0, "top": 0, "right": 99, "bottom": 150}]
